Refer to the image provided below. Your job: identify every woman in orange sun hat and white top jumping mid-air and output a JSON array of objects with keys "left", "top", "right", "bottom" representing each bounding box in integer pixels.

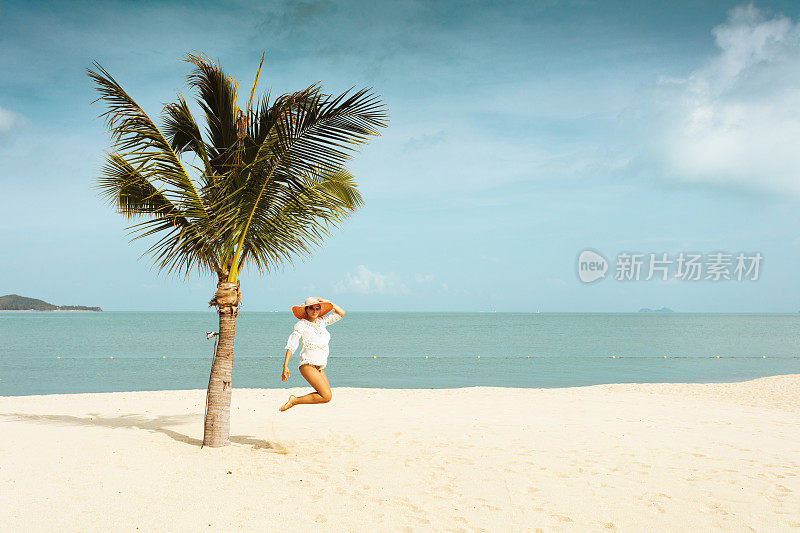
[{"left": 280, "top": 297, "right": 344, "bottom": 411}]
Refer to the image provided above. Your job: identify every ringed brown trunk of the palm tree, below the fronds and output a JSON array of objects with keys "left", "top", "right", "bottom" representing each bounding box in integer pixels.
[{"left": 203, "top": 281, "right": 241, "bottom": 447}]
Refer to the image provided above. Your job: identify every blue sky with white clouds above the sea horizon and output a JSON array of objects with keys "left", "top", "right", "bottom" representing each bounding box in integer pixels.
[{"left": 0, "top": 1, "right": 800, "bottom": 312}]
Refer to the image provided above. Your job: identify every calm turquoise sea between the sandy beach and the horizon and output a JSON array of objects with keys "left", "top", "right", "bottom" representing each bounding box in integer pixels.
[{"left": 0, "top": 311, "right": 800, "bottom": 396}]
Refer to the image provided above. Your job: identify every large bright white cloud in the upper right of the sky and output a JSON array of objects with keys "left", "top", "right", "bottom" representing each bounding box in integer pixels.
[{"left": 653, "top": 5, "right": 800, "bottom": 195}]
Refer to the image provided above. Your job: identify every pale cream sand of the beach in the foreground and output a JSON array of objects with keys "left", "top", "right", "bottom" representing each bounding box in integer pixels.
[{"left": 0, "top": 375, "right": 800, "bottom": 531}]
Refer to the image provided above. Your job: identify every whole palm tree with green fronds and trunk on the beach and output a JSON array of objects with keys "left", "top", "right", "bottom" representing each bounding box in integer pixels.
[{"left": 87, "top": 53, "right": 388, "bottom": 446}]
